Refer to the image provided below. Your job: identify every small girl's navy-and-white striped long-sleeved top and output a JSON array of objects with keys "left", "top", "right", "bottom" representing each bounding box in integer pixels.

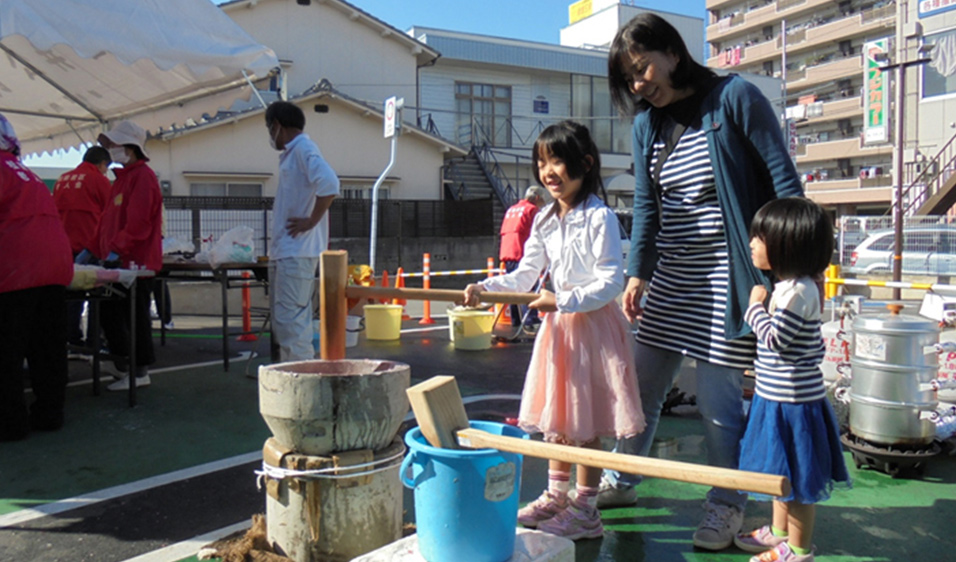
[{"left": 745, "top": 277, "right": 826, "bottom": 402}]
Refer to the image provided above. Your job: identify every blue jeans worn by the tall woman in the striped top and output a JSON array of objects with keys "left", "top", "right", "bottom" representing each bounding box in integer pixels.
[{"left": 604, "top": 336, "right": 747, "bottom": 510}]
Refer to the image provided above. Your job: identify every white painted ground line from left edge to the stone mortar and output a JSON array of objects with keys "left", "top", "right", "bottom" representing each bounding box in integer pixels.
[{"left": 0, "top": 451, "right": 262, "bottom": 529}]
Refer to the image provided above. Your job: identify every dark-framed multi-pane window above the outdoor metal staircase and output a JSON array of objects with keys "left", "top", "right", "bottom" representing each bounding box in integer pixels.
[{"left": 455, "top": 82, "right": 511, "bottom": 148}]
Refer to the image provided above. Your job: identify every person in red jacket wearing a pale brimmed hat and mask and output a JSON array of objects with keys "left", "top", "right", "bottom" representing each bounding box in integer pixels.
[{"left": 97, "top": 121, "right": 163, "bottom": 390}]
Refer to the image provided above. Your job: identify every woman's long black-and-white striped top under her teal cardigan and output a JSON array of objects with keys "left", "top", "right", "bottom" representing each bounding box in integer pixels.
[{"left": 637, "top": 126, "right": 756, "bottom": 369}]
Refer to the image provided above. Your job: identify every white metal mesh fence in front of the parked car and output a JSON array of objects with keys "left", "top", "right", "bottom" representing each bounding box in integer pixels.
[{"left": 835, "top": 216, "right": 956, "bottom": 276}]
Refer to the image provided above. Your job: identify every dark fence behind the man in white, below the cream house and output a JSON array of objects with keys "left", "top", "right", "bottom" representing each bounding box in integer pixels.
[{"left": 164, "top": 197, "right": 496, "bottom": 256}]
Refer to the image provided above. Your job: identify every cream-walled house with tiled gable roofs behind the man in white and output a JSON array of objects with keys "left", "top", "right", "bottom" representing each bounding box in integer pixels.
[{"left": 148, "top": 0, "right": 465, "bottom": 199}]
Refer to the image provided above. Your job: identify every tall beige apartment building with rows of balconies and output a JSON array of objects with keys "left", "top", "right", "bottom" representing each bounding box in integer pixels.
[{"left": 706, "top": 0, "right": 897, "bottom": 214}]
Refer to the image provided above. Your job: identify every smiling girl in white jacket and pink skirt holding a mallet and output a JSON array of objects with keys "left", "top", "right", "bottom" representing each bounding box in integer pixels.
[{"left": 464, "top": 121, "right": 644, "bottom": 540}]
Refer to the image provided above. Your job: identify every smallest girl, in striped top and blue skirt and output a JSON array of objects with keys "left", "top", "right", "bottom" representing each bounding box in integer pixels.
[{"left": 734, "top": 197, "right": 850, "bottom": 562}]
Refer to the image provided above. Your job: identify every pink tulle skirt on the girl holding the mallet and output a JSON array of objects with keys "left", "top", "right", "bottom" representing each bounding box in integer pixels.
[{"left": 518, "top": 302, "right": 645, "bottom": 444}]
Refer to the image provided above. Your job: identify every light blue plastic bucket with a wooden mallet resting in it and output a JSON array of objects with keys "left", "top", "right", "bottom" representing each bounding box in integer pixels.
[{"left": 400, "top": 421, "right": 528, "bottom": 562}]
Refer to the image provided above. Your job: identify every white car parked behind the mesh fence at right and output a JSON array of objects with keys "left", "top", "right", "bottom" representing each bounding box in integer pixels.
[{"left": 844, "top": 225, "right": 956, "bottom": 275}]
